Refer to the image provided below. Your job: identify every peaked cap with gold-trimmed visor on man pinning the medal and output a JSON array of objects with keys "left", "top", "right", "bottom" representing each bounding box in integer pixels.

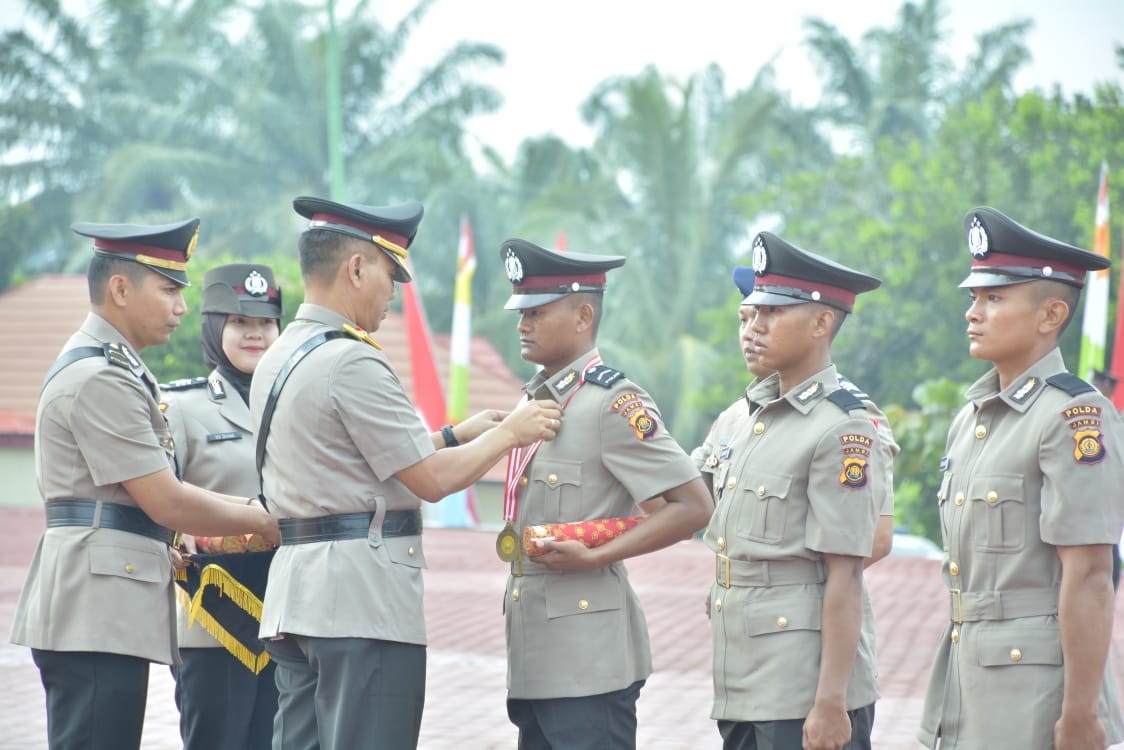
[{"left": 292, "top": 196, "right": 423, "bottom": 283}]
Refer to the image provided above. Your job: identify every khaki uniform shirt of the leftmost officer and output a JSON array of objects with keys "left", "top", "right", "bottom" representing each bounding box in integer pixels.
[{"left": 11, "top": 313, "right": 176, "bottom": 663}]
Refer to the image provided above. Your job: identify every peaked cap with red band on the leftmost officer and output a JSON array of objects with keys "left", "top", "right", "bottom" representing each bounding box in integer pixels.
[{"left": 71, "top": 219, "right": 199, "bottom": 287}]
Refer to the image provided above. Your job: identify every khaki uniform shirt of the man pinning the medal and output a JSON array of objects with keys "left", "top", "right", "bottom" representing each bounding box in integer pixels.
[{"left": 250, "top": 304, "right": 434, "bottom": 644}]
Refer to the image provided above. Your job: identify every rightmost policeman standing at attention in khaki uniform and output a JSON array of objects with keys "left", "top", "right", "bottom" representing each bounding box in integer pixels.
[{"left": 918, "top": 207, "right": 1124, "bottom": 750}]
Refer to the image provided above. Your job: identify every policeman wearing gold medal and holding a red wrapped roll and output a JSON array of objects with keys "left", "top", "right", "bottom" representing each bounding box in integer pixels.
[{"left": 500, "top": 240, "right": 711, "bottom": 750}]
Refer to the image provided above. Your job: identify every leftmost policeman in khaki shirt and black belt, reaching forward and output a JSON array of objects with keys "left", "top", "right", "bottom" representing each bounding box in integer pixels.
[{"left": 12, "top": 219, "right": 278, "bottom": 750}]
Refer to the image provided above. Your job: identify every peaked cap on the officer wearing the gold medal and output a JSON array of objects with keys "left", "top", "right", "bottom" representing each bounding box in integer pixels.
[{"left": 499, "top": 238, "right": 625, "bottom": 310}]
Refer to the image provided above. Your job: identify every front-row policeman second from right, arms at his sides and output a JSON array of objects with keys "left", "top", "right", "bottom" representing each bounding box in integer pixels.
[{"left": 703, "top": 232, "right": 888, "bottom": 750}]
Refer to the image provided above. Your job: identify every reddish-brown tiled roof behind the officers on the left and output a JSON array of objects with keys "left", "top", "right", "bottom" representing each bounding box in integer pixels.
[{"left": 0, "top": 274, "right": 523, "bottom": 480}]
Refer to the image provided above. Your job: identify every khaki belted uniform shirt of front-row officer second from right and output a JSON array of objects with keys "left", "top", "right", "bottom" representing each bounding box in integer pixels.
[{"left": 696, "top": 367, "right": 887, "bottom": 722}]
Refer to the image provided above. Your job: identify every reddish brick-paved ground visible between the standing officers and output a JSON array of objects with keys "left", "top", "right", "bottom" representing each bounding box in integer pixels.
[{"left": 0, "top": 508, "right": 1124, "bottom": 750}]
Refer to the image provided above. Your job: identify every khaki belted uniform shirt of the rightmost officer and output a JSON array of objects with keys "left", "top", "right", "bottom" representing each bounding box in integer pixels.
[{"left": 918, "top": 349, "right": 1124, "bottom": 750}]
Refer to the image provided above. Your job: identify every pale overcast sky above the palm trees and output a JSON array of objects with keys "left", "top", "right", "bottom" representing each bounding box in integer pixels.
[{"left": 0, "top": 0, "right": 1124, "bottom": 156}]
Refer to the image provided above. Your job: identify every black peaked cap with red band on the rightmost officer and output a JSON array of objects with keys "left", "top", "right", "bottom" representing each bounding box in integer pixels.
[{"left": 960, "top": 206, "right": 1111, "bottom": 288}]
